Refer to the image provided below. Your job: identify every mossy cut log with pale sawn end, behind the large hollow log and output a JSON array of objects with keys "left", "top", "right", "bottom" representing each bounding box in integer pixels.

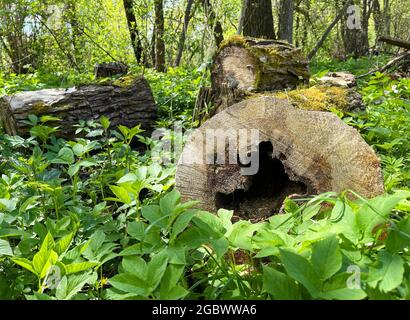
[{"left": 211, "top": 36, "right": 310, "bottom": 112}]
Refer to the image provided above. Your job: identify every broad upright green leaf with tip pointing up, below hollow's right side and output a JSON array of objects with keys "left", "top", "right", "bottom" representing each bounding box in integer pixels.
[{"left": 311, "top": 235, "right": 342, "bottom": 280}]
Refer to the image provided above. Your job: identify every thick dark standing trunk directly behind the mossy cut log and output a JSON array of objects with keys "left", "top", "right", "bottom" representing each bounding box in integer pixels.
[{"left": 243, "top": 0, "right": 275, "bottom": 39}]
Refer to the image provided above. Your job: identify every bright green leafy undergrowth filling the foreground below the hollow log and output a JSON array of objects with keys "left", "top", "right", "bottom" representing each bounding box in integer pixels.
[{"left": 0, "top": 113, "right": 410, "bottom": 300}]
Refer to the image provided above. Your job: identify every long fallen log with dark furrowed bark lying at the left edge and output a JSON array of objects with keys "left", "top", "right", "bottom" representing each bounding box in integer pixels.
[{"left": 0, "top": 76, "right": 157, "bottom": 139}]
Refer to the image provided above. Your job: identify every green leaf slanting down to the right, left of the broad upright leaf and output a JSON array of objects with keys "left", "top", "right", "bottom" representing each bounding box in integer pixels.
[{"left": 279, "top": 249, "right": 319, "bottom": 297}]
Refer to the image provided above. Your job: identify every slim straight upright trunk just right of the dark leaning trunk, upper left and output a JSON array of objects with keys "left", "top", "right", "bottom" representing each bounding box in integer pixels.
[{"left": 154, "top": 0, "right": 165, "bottom": 72}]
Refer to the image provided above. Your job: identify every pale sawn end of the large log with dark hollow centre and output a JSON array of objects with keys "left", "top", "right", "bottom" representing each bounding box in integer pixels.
[{"left": 176, "top": 96, "right": 384, "bottom": 218}]
